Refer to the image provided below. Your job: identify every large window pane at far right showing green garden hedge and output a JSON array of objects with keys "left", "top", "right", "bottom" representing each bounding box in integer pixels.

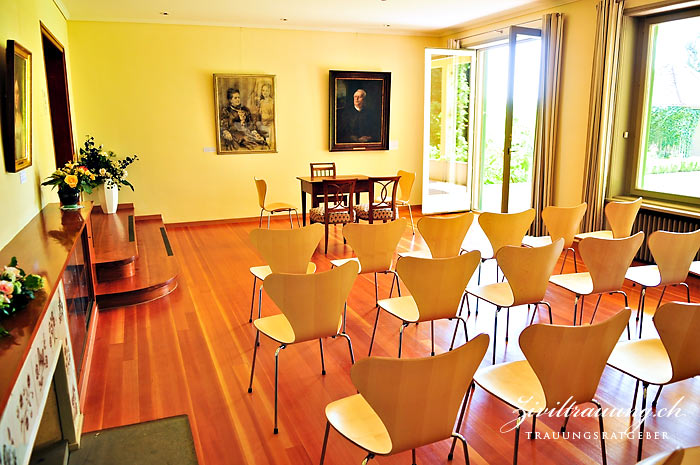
[{"left": 636, "top": 17, "right": 700, "bottom": 197}]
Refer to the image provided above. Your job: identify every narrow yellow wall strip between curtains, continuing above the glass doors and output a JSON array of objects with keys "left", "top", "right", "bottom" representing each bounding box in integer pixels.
[{"left": 443, "top": 0, "right": 596, "bottom": 205}]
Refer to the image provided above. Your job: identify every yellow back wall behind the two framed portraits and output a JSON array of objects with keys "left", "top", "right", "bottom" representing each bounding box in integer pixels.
[{"left": 68, "top": 21, "right": 439, "bottom": 222}]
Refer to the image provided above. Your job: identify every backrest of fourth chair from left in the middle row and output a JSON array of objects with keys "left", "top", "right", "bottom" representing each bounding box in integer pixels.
[{"left": 578, "top": 231, "right": 644, "bottom": 294}]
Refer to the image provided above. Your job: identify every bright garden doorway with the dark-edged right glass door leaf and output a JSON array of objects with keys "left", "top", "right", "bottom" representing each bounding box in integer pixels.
[{"left": 474, "top": 26, "right": 541, "bottom": 213}]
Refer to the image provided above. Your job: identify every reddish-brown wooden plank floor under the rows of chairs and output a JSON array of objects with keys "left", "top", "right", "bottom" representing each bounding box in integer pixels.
[{"left": 84, "top": 220, "right": 700, "bottom": 465}]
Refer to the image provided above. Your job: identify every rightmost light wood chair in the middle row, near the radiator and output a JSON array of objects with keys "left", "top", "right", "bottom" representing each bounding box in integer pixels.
[{"left": 625, "top": 229, "right": 700, "bottom": 339}]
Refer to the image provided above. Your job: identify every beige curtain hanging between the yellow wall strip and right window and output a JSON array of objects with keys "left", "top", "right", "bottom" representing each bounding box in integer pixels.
[{"left": 583, "top": 0, "right": 624, "bottom": 231}]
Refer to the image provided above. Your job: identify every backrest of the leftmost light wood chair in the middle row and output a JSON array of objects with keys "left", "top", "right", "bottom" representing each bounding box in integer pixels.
[{"left": 263, "top": 262, "right": 359, "bottom": 342}]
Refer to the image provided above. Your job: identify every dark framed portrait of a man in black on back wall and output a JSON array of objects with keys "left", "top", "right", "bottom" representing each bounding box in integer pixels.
[{"left": 330, "top": 70, "right": 391, "bottom": 152}]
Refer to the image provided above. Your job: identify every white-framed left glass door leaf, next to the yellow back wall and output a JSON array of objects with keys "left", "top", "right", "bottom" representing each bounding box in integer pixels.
[{"left": 422, "top": 49, "right": 475, "bottom": 214}]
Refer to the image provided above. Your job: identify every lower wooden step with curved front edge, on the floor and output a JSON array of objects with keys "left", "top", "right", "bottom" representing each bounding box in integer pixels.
[{"left": 97, "top": 215, "right": 179, "bottom": 310}]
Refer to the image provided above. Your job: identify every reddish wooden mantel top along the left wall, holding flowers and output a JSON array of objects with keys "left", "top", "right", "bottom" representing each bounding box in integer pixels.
[{"left": 0, "top": 204, "right": 92, "bottom": 411}]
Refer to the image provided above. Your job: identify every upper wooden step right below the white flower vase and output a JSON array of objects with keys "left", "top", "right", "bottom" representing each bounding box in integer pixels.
[{"left": 91, "top": 203, "right": 139, "bottom": 281}]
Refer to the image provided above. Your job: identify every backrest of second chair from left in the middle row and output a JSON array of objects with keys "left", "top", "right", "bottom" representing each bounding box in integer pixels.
[{"left": 396, "top": 250, "right": 481, "bottom": 321}]
